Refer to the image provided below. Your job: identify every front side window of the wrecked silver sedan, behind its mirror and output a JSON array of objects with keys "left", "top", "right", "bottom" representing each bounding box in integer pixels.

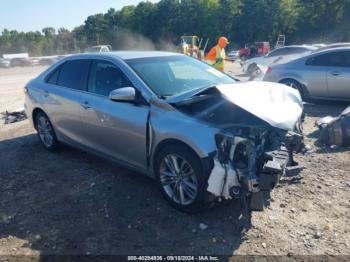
[{"left": 88, "top": 60, "right": 132, "bottom": 96}]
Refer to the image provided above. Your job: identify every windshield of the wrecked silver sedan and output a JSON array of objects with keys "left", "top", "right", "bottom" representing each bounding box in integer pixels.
[{"left": 126, "top": 55, "right": 236, "bottom": 98}]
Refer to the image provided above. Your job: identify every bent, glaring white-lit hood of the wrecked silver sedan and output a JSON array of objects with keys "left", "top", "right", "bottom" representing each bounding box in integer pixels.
[{"left": 217, "top": 81, "right": 303, "bottom": 130}]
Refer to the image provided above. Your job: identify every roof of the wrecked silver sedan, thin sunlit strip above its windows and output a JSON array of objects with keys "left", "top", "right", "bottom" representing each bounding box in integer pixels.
[{"left": 80, "top": 51, "right": 181, "bottom": 60}]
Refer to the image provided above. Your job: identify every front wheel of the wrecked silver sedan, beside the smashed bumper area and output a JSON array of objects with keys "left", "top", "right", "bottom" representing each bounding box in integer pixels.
[{"left": 154, "top": 145, "right": 207, "bottom": 213}]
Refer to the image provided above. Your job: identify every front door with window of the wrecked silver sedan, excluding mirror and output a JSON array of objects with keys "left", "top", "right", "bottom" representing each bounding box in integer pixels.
[{"left": 81, "top": 60, "right": 149, "bottom": 168}]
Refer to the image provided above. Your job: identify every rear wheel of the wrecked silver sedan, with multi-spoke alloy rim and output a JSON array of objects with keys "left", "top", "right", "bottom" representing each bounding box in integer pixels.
[{"left": 35, "top": 112, "right": 59, "bottom": 151}]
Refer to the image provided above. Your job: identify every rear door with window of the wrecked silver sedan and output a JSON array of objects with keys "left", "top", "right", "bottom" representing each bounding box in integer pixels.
[{"left": 43, "top": 59, "right": 91, "bottom": 143}]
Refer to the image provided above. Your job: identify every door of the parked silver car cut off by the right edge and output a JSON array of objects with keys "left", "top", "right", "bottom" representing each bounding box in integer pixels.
[{"left": 327, "top": 51, "right": 350, "bottom": 99}]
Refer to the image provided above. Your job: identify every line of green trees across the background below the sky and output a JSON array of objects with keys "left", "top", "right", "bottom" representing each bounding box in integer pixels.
[{"left": 0, "top": 0, "right": 350, "bottom": 56}]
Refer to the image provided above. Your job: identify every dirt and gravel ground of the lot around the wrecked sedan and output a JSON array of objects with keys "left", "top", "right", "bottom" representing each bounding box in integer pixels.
[{"left": 0, "top": 65, "right": 350, "bottom": 257}]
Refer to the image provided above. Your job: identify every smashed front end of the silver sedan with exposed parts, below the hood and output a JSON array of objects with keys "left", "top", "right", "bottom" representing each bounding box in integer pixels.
[{"left": 207, "top": 127, "right": 303, "bottom": 210}]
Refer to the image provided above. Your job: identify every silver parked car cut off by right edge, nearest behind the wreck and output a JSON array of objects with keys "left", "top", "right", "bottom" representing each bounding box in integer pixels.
[{"left": 264, "top": 47, "right": 350, "bottom": 101}]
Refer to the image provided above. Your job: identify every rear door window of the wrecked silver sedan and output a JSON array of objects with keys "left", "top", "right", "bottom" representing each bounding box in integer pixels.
[{"left": 57, "top": 60, "right": 90, "bottom": 90}]
